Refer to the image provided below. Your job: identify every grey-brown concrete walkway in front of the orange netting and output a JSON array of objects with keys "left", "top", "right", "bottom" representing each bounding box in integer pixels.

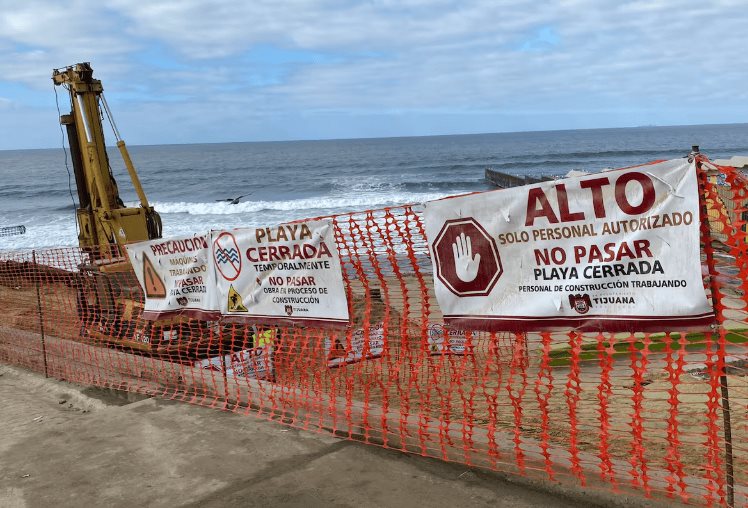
[{"left": 0, "top": 364, "right": 620, "bottom": 508}]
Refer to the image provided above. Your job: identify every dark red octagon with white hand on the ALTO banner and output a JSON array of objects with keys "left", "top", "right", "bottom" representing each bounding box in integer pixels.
[{"left": 433, "top": 217, "right": 503, "bottom": 296}]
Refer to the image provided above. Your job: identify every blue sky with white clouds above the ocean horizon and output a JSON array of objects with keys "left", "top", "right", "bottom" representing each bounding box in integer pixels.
[{"left": 0, "top": 0, "right": 748, "bottom": 149}]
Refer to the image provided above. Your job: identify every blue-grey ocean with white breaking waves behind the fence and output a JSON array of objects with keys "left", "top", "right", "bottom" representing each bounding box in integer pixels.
[{"left": 0, "top": 124, "right": 748, "bottom": 250}]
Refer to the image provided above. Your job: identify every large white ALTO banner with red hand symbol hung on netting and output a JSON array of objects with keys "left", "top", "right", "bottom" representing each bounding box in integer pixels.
[{"left": 425, "top": 159, "right": 713, "bottom": 331}]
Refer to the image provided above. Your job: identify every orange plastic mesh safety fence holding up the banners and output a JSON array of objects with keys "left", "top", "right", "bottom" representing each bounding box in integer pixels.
[{"left": 0, "top": 160, "right": 748, "bottom": 506}]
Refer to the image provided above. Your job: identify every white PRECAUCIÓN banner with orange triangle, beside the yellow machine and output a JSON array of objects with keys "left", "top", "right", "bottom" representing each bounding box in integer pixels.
[{"left": 126, "top": 233, "right": 218, "bottom": 320}]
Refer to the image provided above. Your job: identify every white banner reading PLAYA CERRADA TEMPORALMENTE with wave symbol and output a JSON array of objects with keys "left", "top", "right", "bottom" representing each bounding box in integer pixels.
[{"left": 211, "top": 220, "right": 348, "bottom": 325}]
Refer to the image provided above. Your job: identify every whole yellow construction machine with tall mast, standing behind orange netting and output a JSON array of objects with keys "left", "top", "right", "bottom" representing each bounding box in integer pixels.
[{"left": 52, "top": 62, "right": 219, "bottom": 358}]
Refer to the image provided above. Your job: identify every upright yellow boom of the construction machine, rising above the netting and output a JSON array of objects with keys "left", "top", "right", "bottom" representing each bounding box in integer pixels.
[{"left": 52, "top": 62, "right": 161, "bottom": 259}]
